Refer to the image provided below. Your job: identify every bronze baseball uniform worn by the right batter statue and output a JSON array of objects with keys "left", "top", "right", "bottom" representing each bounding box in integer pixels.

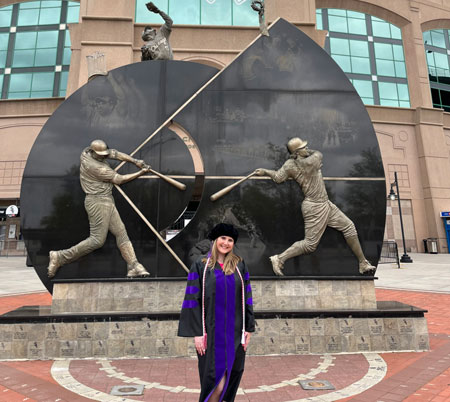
[{"left": 269, "top": 151, "right": 357, "bottom": 258}]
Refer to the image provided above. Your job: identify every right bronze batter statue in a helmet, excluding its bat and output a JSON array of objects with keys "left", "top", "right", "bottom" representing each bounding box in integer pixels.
[{"left": 255, "top": 137, "right": 375, "bottom": 275}]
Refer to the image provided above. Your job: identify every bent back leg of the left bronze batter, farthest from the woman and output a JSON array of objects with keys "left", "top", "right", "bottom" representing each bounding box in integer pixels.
[{"left": 47, "top": 197, "right": 114, "bottom": 278}]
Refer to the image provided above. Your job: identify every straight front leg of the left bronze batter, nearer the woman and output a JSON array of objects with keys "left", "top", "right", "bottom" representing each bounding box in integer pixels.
[{"left": 109, "top": 207, "right": 150, "bottom": 277}]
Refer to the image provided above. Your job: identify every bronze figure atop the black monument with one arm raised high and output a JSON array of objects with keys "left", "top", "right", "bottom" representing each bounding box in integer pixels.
[{"left": 141, "top": 2, "right": 173, "bottom": 61}]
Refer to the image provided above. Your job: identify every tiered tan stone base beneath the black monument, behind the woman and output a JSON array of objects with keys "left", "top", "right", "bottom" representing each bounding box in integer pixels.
[{"left": 0, "top": 278, "right": 429, "bottom": 359}]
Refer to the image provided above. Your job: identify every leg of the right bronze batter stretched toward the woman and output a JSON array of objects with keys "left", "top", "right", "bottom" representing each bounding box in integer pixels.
[{"left": 270, "top": 201, "right": 329, "bottom": 275}]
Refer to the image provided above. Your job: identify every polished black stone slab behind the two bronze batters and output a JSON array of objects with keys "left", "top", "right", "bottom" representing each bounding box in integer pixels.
[{"left": 21, "top": 19, "right": 386, "bottom": 290}]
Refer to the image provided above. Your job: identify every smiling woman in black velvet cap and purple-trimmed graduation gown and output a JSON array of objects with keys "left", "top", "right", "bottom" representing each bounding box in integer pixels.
[{"left": 178, "top": 223, "right": 255, "bottom": 402}]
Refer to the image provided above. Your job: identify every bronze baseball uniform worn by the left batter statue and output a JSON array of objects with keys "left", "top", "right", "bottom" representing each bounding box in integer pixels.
[{"left": 56, "top": 148, "right": 130, "bottom": 265}]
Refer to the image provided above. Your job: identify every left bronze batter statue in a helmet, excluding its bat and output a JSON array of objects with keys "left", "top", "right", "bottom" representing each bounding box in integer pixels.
[{"left": 47, "top": 140, "right": 151, "bottom": 278}]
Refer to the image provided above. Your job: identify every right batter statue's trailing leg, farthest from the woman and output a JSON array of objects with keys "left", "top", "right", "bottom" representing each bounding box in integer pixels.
[{"left": 328, "top": 203, "right": 375, "bottom": 274}]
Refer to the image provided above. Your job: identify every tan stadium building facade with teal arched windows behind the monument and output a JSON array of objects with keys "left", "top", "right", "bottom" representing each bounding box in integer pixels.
[{"left": 0, "top": 0, "right": 450, "bottom": 253}]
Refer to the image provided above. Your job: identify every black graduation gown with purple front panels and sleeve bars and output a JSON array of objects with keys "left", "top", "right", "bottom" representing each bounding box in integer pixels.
[{"left": 178, "top": 259, "right": 255, "bottom": 402}]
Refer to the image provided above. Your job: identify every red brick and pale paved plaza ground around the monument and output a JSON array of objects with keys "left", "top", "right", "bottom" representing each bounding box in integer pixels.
[{"left": 0, "top": 254, "right": 450, "bottom": 402}]
